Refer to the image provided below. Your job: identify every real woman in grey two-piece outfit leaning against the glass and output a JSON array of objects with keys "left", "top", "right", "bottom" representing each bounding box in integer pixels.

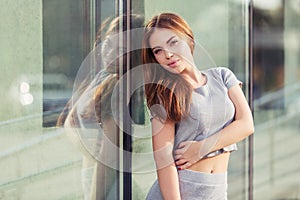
[{"left": 143, "top": 13, "right": 254, "bottom": 200}]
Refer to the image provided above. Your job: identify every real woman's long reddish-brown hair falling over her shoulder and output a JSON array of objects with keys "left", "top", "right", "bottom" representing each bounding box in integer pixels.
[{"left": 142, "top": 13, "right": 194, "bottom": 122}]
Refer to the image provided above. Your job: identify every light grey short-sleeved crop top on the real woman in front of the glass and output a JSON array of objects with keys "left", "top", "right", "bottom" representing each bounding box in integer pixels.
[{"left": 151, "top": 67, "right": 242, "bottom": 157}]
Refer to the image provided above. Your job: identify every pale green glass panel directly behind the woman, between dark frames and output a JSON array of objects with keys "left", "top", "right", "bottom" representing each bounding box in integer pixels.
[{"left": 133, "top": 0, "right": 249, "bottom": 200}]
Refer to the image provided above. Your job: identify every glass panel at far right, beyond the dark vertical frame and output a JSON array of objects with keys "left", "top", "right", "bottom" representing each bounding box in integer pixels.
[{"left": 254, "top": 0, "right": 300, "bottom": 199}]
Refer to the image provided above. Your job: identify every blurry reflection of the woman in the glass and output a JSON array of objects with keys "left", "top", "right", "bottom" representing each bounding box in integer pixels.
[{"left": 58, "top": 15, "right": 143, "bottom": 199}]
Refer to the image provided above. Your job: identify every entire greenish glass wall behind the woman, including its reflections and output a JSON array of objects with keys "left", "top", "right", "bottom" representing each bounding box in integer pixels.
[{"left": 0, "top": 0, "right": 300, "bottom": 200}]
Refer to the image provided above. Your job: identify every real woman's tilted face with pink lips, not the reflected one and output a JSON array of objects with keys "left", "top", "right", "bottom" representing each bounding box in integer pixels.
[{"left": 149, "top": 28, "right": 194, "bottom": 74}]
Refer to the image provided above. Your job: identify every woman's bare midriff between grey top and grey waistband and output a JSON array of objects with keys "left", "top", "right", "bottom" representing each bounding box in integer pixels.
[{"left": 188, "top": 152, "right": 230, "bottom": 173}]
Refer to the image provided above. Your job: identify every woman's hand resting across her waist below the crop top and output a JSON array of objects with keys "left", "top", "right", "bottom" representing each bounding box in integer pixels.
[{"left": 175, "top": 141, "right": 202, "bottom": 170}]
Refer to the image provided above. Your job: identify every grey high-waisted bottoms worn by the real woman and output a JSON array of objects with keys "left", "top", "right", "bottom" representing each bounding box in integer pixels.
[{"left": 147, "top": 169, "right": 227, "bottom": 200}]
